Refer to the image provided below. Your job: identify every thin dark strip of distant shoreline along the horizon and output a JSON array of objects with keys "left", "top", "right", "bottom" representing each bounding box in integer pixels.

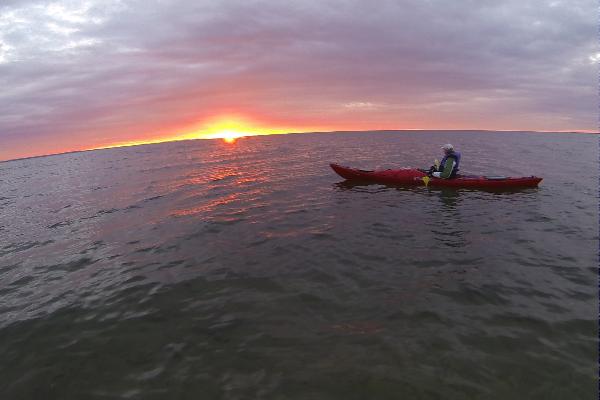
[{"left": 0, "top": 129, "right": 600, "bottom": 164}]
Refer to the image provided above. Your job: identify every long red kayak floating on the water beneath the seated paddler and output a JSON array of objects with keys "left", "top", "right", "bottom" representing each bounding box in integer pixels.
[{"left": 330, "top": 164, "right": 542, "bottom": 189}]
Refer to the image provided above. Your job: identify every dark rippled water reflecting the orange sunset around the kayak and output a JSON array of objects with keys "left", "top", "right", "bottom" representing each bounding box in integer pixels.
[{"left": 0, "top": 132, "right": 598, "bottom": 400}]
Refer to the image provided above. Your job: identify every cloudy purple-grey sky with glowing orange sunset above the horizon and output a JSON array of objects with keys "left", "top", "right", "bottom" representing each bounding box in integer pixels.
[{"left": 0, "top": 0, "right": 600, "bottom": 160}]
